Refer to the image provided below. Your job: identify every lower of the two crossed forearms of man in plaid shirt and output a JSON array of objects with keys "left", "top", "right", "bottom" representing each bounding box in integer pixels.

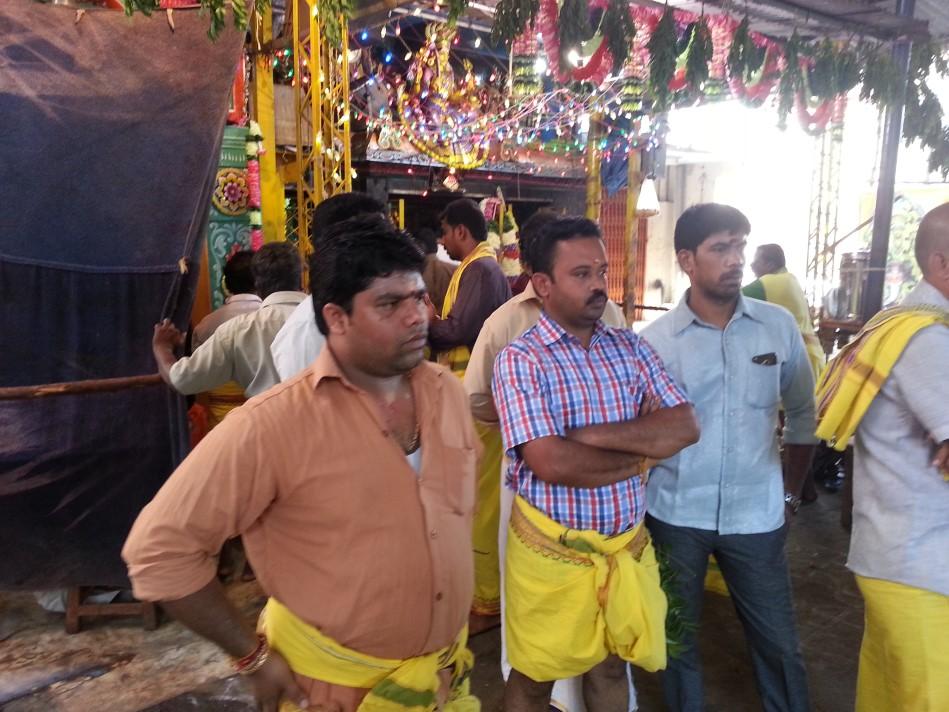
[{"left": 522, "top": 437, "right": 644, "bottom": 488}]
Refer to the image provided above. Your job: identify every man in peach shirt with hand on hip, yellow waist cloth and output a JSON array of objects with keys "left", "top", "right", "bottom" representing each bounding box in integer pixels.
[{"left": 123, "top": 216, "right": 478, "bottom": 712}]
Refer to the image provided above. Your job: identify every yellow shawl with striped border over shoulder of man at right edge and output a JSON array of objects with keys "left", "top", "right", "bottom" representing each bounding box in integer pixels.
[{"left": 817, "top": 305, "right": 949, "bottom": 452}]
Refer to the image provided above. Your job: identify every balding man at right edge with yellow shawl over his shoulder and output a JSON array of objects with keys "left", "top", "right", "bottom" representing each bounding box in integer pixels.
[{"left": 817, "top": 203, "right": 949, "bottom": 712}]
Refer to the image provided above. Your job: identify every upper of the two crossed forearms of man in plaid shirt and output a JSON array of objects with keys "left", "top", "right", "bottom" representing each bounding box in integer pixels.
[{"left": 567, "top": 405, "right": 699, "bottom": 460}]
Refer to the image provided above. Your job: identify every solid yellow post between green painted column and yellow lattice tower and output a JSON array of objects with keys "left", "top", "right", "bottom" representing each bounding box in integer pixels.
[{"left": 251, "top": 7, "right": 287, "bottom": 242}]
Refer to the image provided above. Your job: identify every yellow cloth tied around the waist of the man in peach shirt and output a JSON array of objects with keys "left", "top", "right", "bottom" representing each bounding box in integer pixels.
[{"left": 260, "top": 598, "right": 481, "bottom": 712}]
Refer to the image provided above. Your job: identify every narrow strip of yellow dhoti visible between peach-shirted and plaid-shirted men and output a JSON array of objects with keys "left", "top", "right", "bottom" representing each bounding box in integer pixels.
[{"left": 471, "top": 423, "right": 504, "bottom": 615}]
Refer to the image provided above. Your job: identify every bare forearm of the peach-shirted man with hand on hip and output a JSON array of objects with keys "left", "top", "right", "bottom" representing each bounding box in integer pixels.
[{"left": 161, "top": 578, "right": 257, "bottom": 658}]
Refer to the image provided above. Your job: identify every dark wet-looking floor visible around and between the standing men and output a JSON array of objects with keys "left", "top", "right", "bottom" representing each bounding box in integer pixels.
[{"left": 0, "top": 494, "right": 863, "bottom": 712}]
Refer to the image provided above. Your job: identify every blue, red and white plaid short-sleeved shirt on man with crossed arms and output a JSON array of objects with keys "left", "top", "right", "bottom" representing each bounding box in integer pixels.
[{"left": 491, "top": 312, "right": 689, "bottom": 536}]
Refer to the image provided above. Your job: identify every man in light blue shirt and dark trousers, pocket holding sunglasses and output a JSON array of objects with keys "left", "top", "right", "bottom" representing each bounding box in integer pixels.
[{"left": 642, "top": 203, "right": 816, "bottom": 712}]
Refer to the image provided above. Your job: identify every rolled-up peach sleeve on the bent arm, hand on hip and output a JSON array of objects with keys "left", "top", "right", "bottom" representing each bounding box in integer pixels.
[{"left": 122, "top": 411, "right": 277, "bottom": 601}]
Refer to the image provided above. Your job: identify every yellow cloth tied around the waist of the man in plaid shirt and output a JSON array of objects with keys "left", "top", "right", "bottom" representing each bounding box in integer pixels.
[{"left": 504, "top": 497, "right": 667, "bottom": 682}]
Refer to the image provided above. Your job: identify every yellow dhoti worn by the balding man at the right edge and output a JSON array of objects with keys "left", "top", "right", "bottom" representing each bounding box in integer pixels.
[{"left": 856, "top": 576, "right": 949, "bottom": 712}]
